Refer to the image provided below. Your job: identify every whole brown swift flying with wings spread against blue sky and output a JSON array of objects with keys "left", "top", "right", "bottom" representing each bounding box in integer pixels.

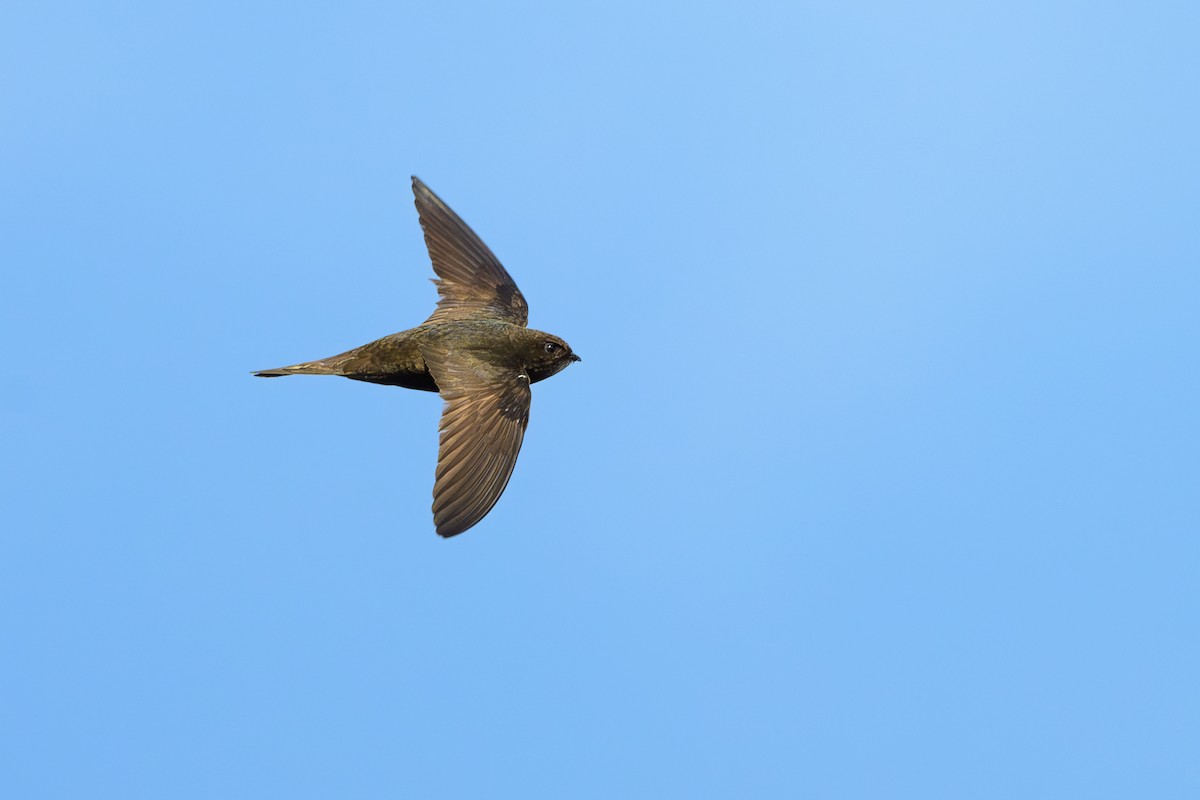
[{"left": 254, "top": 175, "right": 580, "bottom": 536}]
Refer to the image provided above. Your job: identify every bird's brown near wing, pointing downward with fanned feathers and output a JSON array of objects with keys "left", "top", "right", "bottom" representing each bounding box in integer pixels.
[{"left": 421, "top": 344, "right": 530, "bottom": 536}]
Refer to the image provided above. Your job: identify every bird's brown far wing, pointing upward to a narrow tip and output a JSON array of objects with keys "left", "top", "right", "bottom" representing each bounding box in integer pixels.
[{"left": 413, "top": 175, "right": 529, "bottom": 325}]
